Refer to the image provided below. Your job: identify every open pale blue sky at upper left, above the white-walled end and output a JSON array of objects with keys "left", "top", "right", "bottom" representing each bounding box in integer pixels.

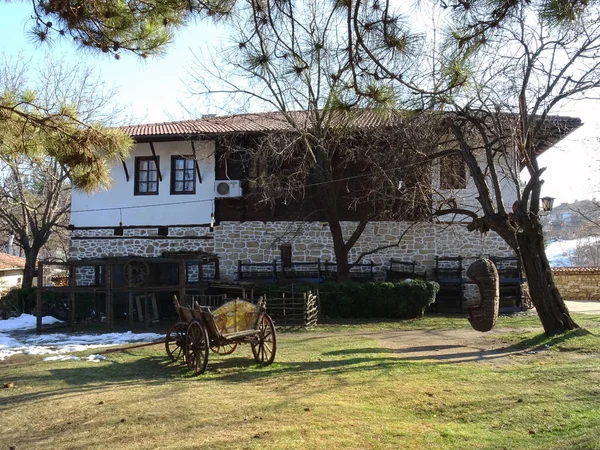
[{"left": 0, "top": 2, "right": 224, "bottom": 123}]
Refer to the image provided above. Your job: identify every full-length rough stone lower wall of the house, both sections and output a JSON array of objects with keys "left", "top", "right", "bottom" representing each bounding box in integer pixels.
[{"left": 71, "top": 222, "right": 512, "bottom": 280}]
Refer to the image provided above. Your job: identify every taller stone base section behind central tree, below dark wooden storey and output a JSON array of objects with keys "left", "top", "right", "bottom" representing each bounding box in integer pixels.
[{"left": 214, "top": 222, "right": 513, "bottom": 278}]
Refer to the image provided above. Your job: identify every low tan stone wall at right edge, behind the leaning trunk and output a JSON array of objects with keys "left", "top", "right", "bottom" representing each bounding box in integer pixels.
[{"left": 552, "top": 267, "right": 600, "bottom": 300}]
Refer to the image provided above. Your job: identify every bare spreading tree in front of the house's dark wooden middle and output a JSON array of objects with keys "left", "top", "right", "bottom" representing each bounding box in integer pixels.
[{"left": 192, "top": 0, "right": 458, "bottom": 279}]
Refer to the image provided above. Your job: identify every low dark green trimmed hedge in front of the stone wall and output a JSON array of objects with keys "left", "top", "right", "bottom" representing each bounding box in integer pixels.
[{"left": 254, "top": 280, "right": 439, "bottom": 319}]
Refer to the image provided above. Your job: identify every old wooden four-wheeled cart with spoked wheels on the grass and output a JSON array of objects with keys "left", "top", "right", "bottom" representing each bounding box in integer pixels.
[{"left": 165, "top": 297, "right": 277, "bottom": 374}]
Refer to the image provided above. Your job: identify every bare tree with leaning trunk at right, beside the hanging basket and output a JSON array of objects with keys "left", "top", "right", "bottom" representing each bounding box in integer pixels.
[{"left": 438, "top": 9, "right": 600, "bottom": 335}]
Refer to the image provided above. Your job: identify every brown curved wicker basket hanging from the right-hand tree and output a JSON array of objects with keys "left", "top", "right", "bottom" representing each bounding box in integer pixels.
[{"left": 467, "top": 258, "right": 500, "bottom": 331}]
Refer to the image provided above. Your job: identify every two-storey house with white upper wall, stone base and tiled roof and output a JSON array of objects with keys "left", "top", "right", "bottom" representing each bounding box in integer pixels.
[{"left": 70, "top": 112, "right": 580, "bottom": 292}]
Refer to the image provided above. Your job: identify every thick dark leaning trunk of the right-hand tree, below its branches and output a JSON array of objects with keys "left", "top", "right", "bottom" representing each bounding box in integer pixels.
[{"left": 517, "top": 229, "right": 579, "bottom": 336}]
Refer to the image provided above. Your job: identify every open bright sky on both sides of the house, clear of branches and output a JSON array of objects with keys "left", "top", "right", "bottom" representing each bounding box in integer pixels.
[{"left": 0, "top": 2, "right": 600, "bottom": 203}]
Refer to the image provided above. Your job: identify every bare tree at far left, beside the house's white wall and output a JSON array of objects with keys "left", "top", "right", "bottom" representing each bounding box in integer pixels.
[{"left": 0, "top": 56, "right": 129, "bottom": 287}]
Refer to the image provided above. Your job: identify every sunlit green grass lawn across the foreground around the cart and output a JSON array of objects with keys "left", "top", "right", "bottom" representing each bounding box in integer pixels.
[{"left": 0, "top": 315, "right": 600, "bottom": 450}]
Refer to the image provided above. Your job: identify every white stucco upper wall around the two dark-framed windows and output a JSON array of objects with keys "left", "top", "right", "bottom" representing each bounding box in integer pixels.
[{"left": 71, "top": 141, "right": 215, "bottom": 227}]
